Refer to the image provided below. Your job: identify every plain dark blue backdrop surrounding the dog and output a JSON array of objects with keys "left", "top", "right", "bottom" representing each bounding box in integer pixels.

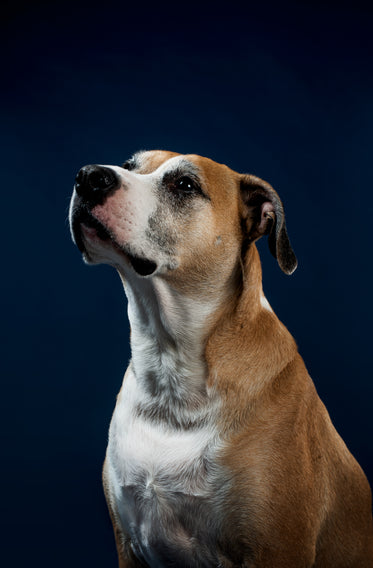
[{"left": 1, "top": 0, "right": 373, "bottom": 568}]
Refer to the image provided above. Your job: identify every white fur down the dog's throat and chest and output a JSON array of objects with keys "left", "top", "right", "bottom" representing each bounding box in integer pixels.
[{"left": 106, "top": 273, "right": 224, "bottom": 566}]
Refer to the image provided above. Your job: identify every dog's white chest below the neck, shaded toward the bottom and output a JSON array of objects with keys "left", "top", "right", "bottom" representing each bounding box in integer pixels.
[{"left": 107, "top": 372, "right": 224, "bottom": 567}]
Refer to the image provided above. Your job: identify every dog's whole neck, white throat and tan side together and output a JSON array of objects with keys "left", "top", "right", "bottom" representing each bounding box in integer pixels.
[{"left": 116, "top": 245, "right": 296, "bottom": 427}]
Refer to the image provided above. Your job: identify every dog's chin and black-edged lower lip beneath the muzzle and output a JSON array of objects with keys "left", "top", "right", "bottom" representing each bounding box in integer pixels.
[{"left": 74, "top": 220, "right": 158, "bottom": 277}]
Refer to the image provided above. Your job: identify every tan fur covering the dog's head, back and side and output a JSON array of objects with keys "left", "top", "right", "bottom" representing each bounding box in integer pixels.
[{"left": 72, "top": 151, "right": 373, "bottom": 568}]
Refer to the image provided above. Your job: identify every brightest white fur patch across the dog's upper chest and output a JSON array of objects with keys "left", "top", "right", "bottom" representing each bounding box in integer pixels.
[{"left": 108, "top": 370, "right": 217, "bottom": 495}]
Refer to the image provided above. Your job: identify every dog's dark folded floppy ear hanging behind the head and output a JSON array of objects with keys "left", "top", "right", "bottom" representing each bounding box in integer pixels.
[{"left": 240, "top": 174, "right": 298, "bottom": 274}]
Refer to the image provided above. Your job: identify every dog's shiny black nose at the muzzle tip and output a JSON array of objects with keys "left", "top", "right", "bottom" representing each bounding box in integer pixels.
[{"left": 75, "top": 164, "right": 120, "bottom": 201}]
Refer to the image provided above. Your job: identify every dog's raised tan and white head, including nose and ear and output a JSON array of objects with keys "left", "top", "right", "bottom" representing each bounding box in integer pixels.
[{"left": 70, "top": 151, "right": 296, "bottom": 282}]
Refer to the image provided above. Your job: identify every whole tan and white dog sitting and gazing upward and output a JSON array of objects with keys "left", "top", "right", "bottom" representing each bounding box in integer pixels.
[{"left": 69, "top": 150, "right": 373, "bottom": 568}]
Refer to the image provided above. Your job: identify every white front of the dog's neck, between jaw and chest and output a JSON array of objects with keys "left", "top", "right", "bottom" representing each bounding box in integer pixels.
[{"left": 118, "top": 268, "right": 217, "bottom": 411}]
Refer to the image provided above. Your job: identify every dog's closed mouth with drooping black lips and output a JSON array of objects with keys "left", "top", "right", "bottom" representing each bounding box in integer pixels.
[{"left": 72, "top": 208, "right": 158, "bottom": 276}]
